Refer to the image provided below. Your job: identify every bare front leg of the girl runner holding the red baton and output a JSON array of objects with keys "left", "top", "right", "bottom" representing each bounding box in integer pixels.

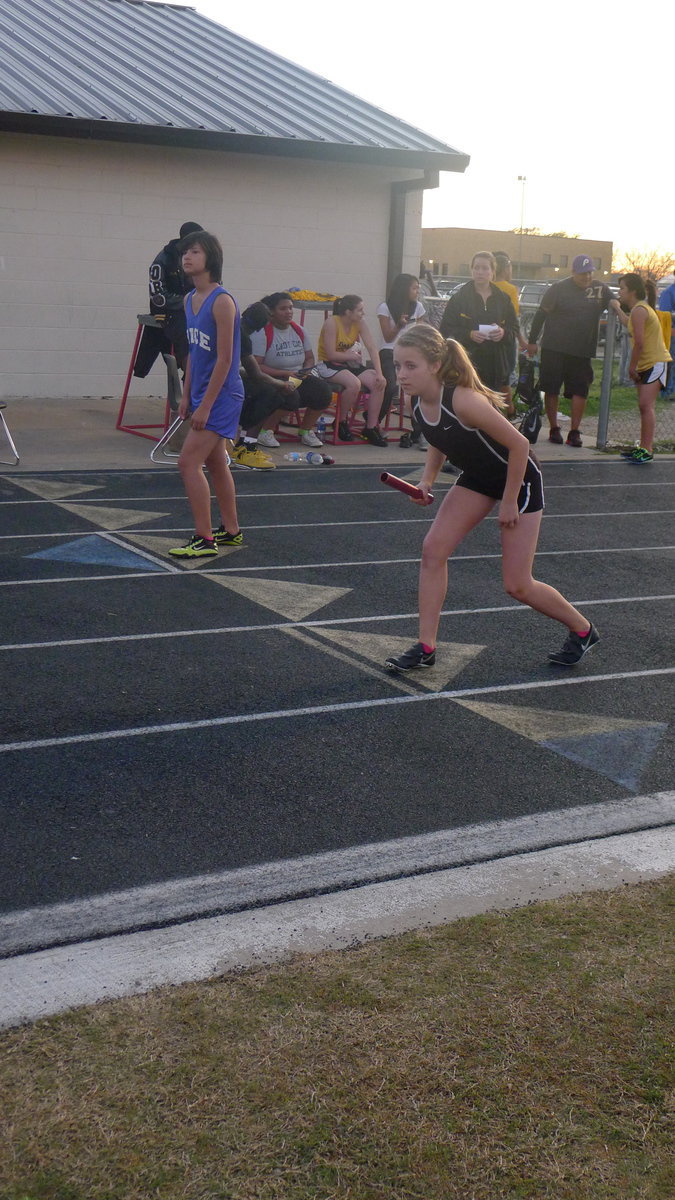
[{"left": 419, "top": 487, "right": 496, "bottom": 647}]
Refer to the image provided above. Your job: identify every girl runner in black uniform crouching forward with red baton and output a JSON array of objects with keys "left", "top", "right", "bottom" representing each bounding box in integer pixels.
[{"left": 386, "top": 325, "right": 599, "bottom": 671}]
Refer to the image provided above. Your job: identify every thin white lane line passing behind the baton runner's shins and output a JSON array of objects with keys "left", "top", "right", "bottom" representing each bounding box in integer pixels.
[{"left": 0, "top": 585, "right": 675, "bottom": 650}]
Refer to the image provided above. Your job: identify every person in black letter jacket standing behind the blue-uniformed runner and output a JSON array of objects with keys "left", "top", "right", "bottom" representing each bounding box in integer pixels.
[{"left": 133, "top": 221, "right": 202, "bottom": 379}]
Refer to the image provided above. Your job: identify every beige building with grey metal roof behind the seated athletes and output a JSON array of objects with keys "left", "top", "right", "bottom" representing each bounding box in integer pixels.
[{"left": 0, "top": 0, "right": 468, "bottom": 397}]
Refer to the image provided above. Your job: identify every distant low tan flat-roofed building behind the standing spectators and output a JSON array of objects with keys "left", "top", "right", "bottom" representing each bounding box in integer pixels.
[{"left": 422, "top": 227, "right": 614, "bottom": 282}]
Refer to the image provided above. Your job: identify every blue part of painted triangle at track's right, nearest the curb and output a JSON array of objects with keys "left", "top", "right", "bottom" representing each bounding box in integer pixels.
[{"left": 539, "top": 725, "right": 668, "bottom": 792}]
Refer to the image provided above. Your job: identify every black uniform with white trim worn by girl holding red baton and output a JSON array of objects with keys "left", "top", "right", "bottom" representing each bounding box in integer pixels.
[{"left": 412, "top": 386, "right": 544, "bottom": 512}]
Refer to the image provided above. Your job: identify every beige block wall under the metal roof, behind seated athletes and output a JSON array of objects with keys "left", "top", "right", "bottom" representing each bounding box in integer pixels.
[{"left": 0, "top": 134, "right": 422, "bottom": 397}]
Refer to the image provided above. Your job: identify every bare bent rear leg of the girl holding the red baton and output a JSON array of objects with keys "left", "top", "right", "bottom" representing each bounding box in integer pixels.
[{"left": 502, "top": 512, "right": 591, "bottom": 634}]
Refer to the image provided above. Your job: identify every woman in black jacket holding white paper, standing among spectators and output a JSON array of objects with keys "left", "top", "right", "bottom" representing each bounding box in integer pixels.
[{"left": 441, "top": 250, "right": 519, "bottom": 392}]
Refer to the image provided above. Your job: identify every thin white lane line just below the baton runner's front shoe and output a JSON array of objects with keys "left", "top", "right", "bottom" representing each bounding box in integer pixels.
[{"left": 0, "top": 667, "right": 675, "bottom": 754}]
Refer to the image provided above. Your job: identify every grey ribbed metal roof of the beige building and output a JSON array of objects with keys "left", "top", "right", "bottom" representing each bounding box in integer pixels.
[{"left": 0, "top": 0, "right": 468, "bottom": 170}]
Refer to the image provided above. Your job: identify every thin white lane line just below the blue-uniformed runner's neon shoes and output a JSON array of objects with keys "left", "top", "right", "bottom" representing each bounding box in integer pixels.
[{"left": 0, "top": 544, "right": 675, "bottom": 588}]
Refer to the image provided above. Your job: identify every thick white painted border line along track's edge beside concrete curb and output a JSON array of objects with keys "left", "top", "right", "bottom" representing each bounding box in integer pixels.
[{"left": 0, "top": 792, "right": 675, "bottom": 954}]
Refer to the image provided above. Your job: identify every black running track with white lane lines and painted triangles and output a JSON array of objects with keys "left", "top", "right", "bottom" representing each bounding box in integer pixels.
[{"left": 0, "top": 461, "right": 675, "bottom": 946}]
